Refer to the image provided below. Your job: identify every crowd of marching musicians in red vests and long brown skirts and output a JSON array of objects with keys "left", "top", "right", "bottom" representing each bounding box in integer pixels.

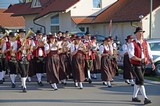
[{"left": 0, "top": 29, "right": 118, "bottom": 92}]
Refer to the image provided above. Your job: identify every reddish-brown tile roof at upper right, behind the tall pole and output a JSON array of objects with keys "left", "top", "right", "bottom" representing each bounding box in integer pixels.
[{"left": 95, "top": 0, "right": 160, "bottom": 23}]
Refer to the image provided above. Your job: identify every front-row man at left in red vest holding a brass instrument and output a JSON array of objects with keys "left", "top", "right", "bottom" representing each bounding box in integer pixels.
[{"left": 13, "top": 29, "right": 31, "bottom": 92}]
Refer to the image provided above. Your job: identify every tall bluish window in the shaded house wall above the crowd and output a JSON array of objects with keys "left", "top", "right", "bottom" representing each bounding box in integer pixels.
[{"left": 51, "top": 15, "right": 59, "bottom": 33}]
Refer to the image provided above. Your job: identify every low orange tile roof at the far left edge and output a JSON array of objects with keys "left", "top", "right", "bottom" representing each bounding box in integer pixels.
[{"left": 0, "top": 9, "right": 25, "bottom": 27}]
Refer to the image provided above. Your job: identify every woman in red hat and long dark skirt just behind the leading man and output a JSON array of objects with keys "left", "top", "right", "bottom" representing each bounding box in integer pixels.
[{"left": 122, "top": 35, "right": 134, "bottom": 86}]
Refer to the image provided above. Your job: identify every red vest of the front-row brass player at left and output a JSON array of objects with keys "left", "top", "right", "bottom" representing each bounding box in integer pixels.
[{"left": 16, "top": 39, "right": 31, "bottom": 60}]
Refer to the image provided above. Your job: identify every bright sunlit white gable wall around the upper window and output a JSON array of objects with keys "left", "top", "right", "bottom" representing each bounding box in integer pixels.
[{"left": 71, "top": 0, "right": 117, "bottom": 16}]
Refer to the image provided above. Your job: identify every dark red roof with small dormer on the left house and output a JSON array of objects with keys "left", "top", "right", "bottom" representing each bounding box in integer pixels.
[{"left": 6, "top": 0, "right": 80, "bottom": 18}]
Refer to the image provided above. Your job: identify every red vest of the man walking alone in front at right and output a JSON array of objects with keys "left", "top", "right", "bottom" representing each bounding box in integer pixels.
[{"left": 130, "top": 40, "right": 149, "bottom": 65}]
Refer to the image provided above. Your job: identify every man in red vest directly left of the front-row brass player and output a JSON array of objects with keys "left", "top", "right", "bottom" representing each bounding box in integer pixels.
[{"left": 2, "top": 32, "right": 17, "bottom": 88}]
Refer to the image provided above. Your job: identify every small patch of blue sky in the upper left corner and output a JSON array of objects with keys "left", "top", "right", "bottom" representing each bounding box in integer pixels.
[{"left": 0, "top": 0, "right": 19, "bottom": 8}]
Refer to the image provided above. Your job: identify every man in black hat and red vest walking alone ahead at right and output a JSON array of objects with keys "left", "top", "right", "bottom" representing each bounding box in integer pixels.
[{"left": 128, "top": 27, "right": 155, "bottom": 104}]
